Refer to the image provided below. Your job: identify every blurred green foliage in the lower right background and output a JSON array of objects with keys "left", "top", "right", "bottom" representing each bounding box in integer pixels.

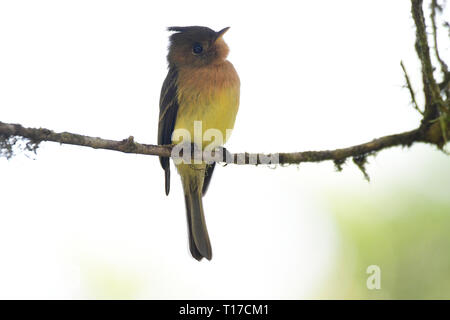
[{"left": 323, "top": 189, "right": 450, "bottom": 299}]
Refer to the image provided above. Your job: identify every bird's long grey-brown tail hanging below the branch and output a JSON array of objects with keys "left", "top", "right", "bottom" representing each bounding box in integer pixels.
[{"left": 180, "top": 168, "right": 212, "bottom": 261}]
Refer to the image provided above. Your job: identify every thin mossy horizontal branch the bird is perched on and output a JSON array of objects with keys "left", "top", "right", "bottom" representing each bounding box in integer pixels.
[{"left": 0, "top": 122, "right": 441, "bottom": 164}]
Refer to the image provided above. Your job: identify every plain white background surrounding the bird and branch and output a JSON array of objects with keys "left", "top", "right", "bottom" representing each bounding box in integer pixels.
[{"left": 0, "top": 0, "right": 449, "bottom": 299}]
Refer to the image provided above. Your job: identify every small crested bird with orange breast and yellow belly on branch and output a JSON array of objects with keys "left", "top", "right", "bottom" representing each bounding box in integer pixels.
[{"left": 158, "top": 26, "right": 240, "bottom": 261}]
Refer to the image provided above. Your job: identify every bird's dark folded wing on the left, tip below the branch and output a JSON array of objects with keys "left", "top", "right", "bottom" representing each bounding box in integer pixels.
[{"left": 158, "top": 68, "right": 178, "bottom": 195}]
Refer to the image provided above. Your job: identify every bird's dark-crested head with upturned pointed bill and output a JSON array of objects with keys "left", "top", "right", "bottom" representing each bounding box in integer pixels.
[{"left": 167, "top": 26, "right": 229, "bottom": 67}]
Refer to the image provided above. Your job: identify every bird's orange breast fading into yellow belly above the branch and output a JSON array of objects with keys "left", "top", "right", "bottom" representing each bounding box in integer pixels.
[{"left": 172, "top": 61, "right": 240, "bottom": 147}]
